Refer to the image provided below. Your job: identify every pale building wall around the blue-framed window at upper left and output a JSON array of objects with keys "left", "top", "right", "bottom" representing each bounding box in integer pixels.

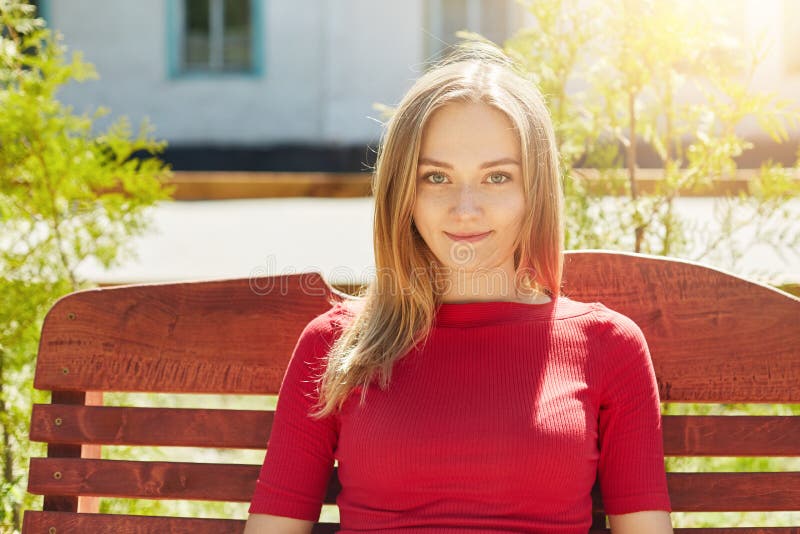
[{"left": 50, "top": 0, "right": 422, "bottom": 146}]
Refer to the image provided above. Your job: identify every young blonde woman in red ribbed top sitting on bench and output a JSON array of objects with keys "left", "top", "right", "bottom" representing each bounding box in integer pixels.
[{"left": 246, "top": 46, "right": 672, "bottom": 534}]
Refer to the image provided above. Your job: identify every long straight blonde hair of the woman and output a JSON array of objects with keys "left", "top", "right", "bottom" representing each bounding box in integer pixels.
[{"left": 311, "top": 43, "right": 564, "bottom": 418}]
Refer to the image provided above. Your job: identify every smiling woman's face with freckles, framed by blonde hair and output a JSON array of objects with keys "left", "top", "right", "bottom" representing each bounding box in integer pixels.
[{"left": 413, "top": 102, "right": 525, "bottom": 279}]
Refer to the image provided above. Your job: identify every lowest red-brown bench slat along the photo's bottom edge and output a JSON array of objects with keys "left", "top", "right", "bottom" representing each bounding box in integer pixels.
[{"left": 17, "top": 510, "right": 800, "bottom": 534}]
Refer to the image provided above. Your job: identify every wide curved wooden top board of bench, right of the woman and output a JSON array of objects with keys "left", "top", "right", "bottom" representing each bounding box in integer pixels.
[{"left": 563, "top": 251, "right": 800, "bottom": 403}]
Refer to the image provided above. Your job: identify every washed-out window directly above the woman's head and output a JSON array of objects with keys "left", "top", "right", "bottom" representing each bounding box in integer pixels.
[{"left": 425, "top": 0, "right": 522, "bottom": 59}]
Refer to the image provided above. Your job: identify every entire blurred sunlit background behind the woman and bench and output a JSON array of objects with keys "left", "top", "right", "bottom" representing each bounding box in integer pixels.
[{"left": 0, "top": 0, "right": 800, "bottom": 532}]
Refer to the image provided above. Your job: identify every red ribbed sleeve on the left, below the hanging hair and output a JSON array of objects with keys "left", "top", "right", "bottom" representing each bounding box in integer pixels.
[{"left": 249, "top": 312, "right": 338, "bottom": 521}]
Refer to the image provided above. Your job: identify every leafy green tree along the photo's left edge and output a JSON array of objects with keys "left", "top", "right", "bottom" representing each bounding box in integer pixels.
[{"left": 0, "top": 0, "right": 172, "bottom": 531}]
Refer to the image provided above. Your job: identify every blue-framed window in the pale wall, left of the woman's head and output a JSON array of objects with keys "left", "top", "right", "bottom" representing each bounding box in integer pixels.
[{"left": 170, "top": 0, "right": 262, "bottom": 75}]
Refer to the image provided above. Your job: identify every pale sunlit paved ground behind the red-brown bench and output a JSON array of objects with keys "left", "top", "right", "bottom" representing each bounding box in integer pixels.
[{"left": 73, "top": 197, "right": 800, "bottom": 283}]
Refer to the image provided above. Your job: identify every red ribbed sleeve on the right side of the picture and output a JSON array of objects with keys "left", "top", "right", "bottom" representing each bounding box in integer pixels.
[{"left": 598, "top": 308, "right": 672, "bottom": 515}]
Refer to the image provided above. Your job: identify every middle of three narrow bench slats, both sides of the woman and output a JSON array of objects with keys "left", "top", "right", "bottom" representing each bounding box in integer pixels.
[{"left": 28, "top": 458, "right": 800, "bottom": 512}]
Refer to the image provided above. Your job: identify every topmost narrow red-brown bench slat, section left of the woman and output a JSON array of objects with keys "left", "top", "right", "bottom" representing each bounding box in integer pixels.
[{"left": 30, "top": 404, "right": 275, "bottom": 449}]
